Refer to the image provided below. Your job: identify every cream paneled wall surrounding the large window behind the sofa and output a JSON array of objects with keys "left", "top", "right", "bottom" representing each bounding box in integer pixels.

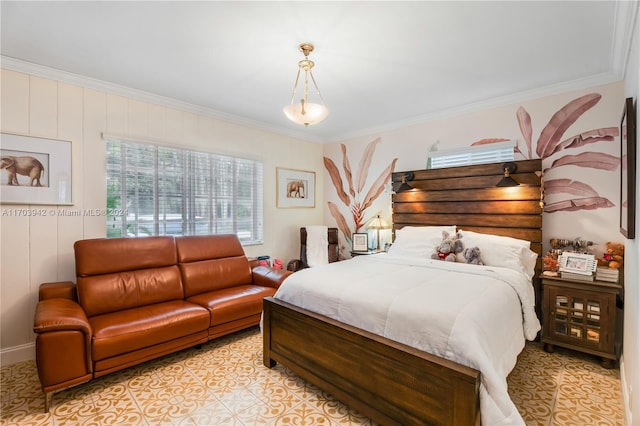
[{"left": 0, "top": 69, "right": 324, "bottom": 364}]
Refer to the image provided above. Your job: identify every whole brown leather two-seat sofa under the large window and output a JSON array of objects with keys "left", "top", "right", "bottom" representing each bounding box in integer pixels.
[{"left": 34, "top": 235, "right": 291, "bottom": 412}]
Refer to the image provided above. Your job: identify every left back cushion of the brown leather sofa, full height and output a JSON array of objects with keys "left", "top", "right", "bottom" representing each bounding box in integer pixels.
[{"left": 74, "top": 237, "right": 184, "bottom": 317}]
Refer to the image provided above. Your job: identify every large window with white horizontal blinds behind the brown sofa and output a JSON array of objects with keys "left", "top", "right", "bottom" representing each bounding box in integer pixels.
[{"left": 106, "top": 139, "right": 263, "bottom": 245}]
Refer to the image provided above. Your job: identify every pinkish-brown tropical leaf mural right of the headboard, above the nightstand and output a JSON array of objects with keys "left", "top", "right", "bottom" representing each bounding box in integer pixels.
[{"left": 472, "top": 93, "right": 620, "bottom": 213}]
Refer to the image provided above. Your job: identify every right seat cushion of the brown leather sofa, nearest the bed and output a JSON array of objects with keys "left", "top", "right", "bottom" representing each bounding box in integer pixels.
[{"left": 187, "top": 285, "right": 276, "bottom": 327}]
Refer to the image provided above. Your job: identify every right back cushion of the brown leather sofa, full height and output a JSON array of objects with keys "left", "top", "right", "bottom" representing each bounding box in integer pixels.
[{"left": 176, "top": 234, "right": 253, "bottom": 297}]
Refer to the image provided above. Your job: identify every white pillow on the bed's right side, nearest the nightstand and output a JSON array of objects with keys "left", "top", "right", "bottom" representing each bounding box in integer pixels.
[{"left": 458, "top": 230, "right": 538, "bottom": 280}]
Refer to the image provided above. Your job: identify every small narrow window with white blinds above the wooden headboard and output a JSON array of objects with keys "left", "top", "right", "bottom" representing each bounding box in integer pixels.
[{"left": 427, "top": 141, "right": 516, "bottom": 169}]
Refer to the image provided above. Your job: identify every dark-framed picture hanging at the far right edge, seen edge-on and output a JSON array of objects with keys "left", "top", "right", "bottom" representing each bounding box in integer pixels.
[{"left": 620, "top": 98, "right": 636, "bottom": 239}]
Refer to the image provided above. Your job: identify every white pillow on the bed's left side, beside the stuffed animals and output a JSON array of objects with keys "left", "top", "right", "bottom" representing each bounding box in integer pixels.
[{"left": 389, "top": 225, "right": 456, "bottom": 259}]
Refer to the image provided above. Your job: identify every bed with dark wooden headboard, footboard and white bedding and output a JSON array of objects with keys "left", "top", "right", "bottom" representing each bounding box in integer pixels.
[{"left": 263, "top": 160, "right": 542, "bottom": 425}]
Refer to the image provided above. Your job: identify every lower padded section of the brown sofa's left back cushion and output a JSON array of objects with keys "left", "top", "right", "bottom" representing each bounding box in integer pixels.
[{"left": 77, "top": 265, "right": 184, "bottom": 317}]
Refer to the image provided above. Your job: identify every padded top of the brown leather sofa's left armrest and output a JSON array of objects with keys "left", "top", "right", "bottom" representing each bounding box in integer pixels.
[{"left": 33, "top": 298, "right": 92, "bottom": 341}]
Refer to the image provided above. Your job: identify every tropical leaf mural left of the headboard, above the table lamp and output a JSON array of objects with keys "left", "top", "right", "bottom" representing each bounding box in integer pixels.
[{"left": 323, "top": 138, "right": 398, "bottom": 248}]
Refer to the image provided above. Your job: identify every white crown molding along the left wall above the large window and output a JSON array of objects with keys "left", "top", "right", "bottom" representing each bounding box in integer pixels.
[{"left": 0, "top": 55, "right": 326, "bottom": 143}]
